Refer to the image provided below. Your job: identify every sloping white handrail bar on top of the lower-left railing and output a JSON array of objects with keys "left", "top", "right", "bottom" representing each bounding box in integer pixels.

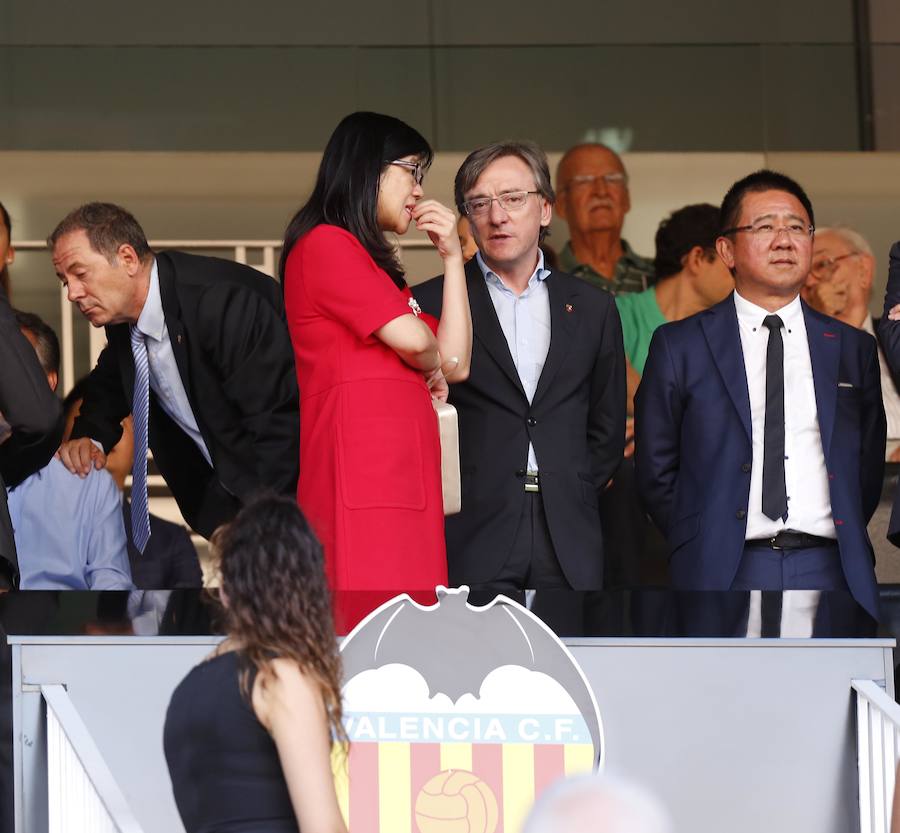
[{"left": 41, "top": 685, "right": 143, "bottom": 833}]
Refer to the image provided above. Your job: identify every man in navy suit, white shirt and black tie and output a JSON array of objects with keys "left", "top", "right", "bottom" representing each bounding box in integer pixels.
[{"left": 635, "top": 170, "right": 885, "bottom": 617}]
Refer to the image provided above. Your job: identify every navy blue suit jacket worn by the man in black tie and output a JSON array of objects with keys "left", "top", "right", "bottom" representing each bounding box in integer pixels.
[{"left": 635, "top": 296, "right": 886, "bottom": 616}]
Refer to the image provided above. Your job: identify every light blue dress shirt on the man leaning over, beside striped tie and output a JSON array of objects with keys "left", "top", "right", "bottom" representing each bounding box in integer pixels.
[{"left": 135, "top": 258, "right": 212, "bottom": 466}]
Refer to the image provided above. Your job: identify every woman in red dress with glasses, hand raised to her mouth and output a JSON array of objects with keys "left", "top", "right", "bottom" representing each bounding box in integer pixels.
[{"left": 280, "top": 113, "right": 472, "bottom": 591}]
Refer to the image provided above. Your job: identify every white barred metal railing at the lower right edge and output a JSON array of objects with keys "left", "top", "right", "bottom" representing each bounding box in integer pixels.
[{"left": 851, "top": 680, "right": 900, "bottom": 833}]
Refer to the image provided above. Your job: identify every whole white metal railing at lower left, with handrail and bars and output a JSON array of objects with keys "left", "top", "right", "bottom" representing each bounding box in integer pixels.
[{"left": 41, "top": 685, "right": 143, "bottom": 833}]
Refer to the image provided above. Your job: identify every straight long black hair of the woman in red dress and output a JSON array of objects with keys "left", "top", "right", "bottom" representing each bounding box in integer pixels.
[{"left": 278, "top": 112, "right": 434, "bottom": 288}]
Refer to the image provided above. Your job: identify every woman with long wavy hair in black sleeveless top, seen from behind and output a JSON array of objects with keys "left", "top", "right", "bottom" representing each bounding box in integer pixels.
[{"left": 163, "top": 496, "right": 346, "bottom": 833}]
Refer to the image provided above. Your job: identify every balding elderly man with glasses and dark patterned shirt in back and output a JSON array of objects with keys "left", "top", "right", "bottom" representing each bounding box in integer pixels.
[{"left": 555, "top": 144, "right": 653, "bottom": 295}]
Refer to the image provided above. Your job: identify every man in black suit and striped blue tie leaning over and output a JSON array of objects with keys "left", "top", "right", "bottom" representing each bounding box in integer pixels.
[{"left": 54, "top": 203, "right": 300, "bottom": 551}]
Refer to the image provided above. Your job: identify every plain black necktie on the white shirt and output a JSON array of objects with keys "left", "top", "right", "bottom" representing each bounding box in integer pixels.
[{"left": 763, "top": 315, "right": 787, "bottom": 521}]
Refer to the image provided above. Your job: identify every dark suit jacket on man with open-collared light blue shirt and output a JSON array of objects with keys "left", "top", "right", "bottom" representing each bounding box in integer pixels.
[{"left": 413, "top": 259, "right": 625, "bottom": 590}]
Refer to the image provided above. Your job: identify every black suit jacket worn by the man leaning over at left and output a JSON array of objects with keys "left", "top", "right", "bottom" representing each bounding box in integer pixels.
[{"left": 72, "top": 252, "right": 300, "bottom": 537}]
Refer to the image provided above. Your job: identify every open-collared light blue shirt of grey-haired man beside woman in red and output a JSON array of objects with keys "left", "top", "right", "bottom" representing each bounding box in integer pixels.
[{"left": 475, "top": 249, "right": 550, "bottom": 472}]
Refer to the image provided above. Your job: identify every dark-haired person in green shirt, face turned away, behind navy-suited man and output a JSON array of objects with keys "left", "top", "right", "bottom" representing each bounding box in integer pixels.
[{"left": 616, "top": 203, "right": 734, "bottom": 375}]
